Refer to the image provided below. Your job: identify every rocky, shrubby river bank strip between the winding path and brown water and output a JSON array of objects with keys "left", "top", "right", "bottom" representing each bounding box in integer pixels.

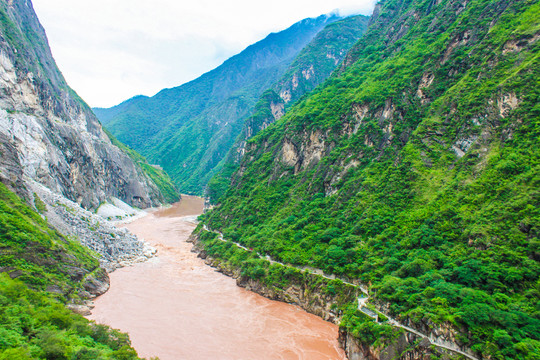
[{"left": 188, "top": 224, "right": 476, "bottom": 360}]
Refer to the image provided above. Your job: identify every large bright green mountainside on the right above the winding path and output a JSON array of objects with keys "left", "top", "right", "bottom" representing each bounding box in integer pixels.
[{"left": 205, "top": 0, "right": 540, "bottom": 359}]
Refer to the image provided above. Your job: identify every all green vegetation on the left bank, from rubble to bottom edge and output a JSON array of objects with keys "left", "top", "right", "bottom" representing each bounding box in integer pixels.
[{"left": 0, "top": 183, "right": 143, "bottom": 360}]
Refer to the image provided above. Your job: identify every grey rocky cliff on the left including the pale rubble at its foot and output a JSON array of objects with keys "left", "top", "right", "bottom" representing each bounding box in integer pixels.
[{"left": 0, "top": 0, "right": 176, "bottom": 270}]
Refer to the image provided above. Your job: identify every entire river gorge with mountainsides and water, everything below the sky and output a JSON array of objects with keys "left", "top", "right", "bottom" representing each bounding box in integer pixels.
[{"left": 0, "top": 0, "right": 540, "bottom": 360}]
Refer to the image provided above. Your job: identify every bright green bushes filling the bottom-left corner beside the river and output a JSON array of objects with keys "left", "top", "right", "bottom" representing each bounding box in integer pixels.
[{"left": 0, "top": 273, "right": 138, "bottom": 360}]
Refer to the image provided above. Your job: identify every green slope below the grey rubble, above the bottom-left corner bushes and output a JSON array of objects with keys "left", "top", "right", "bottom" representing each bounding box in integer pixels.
[{"left": 0, "top": 183, "right": 100, "bottom": 300}]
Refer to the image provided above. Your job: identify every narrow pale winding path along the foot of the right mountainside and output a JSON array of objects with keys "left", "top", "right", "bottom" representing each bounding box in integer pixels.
[{"left": 203, "top": 224, "right": 480, "bottom": 360}]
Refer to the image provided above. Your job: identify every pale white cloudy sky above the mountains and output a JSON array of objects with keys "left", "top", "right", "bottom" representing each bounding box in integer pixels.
[{"left": 32, "top": 0, "right": 376, "bottom": 107}]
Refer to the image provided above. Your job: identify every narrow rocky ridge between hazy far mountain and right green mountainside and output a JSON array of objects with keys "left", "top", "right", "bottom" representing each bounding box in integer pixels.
[{"left": 206, "top": 15, "right": 369, "bottom": 202}]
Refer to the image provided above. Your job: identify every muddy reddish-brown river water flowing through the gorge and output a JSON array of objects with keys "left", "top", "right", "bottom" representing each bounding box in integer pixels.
[{"left": 89, "top": 196, "right": 346, "bottom": 360}]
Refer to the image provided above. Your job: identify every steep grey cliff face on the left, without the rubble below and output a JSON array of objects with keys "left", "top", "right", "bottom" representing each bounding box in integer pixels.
[{"left": 0, "top": 0, "right": 162, "bottom": 209}]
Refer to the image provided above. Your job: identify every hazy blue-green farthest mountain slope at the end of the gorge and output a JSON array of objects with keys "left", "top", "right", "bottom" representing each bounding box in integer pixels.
[{"left": 94, "top": 16, "right": 339, "bottom": 193}]
